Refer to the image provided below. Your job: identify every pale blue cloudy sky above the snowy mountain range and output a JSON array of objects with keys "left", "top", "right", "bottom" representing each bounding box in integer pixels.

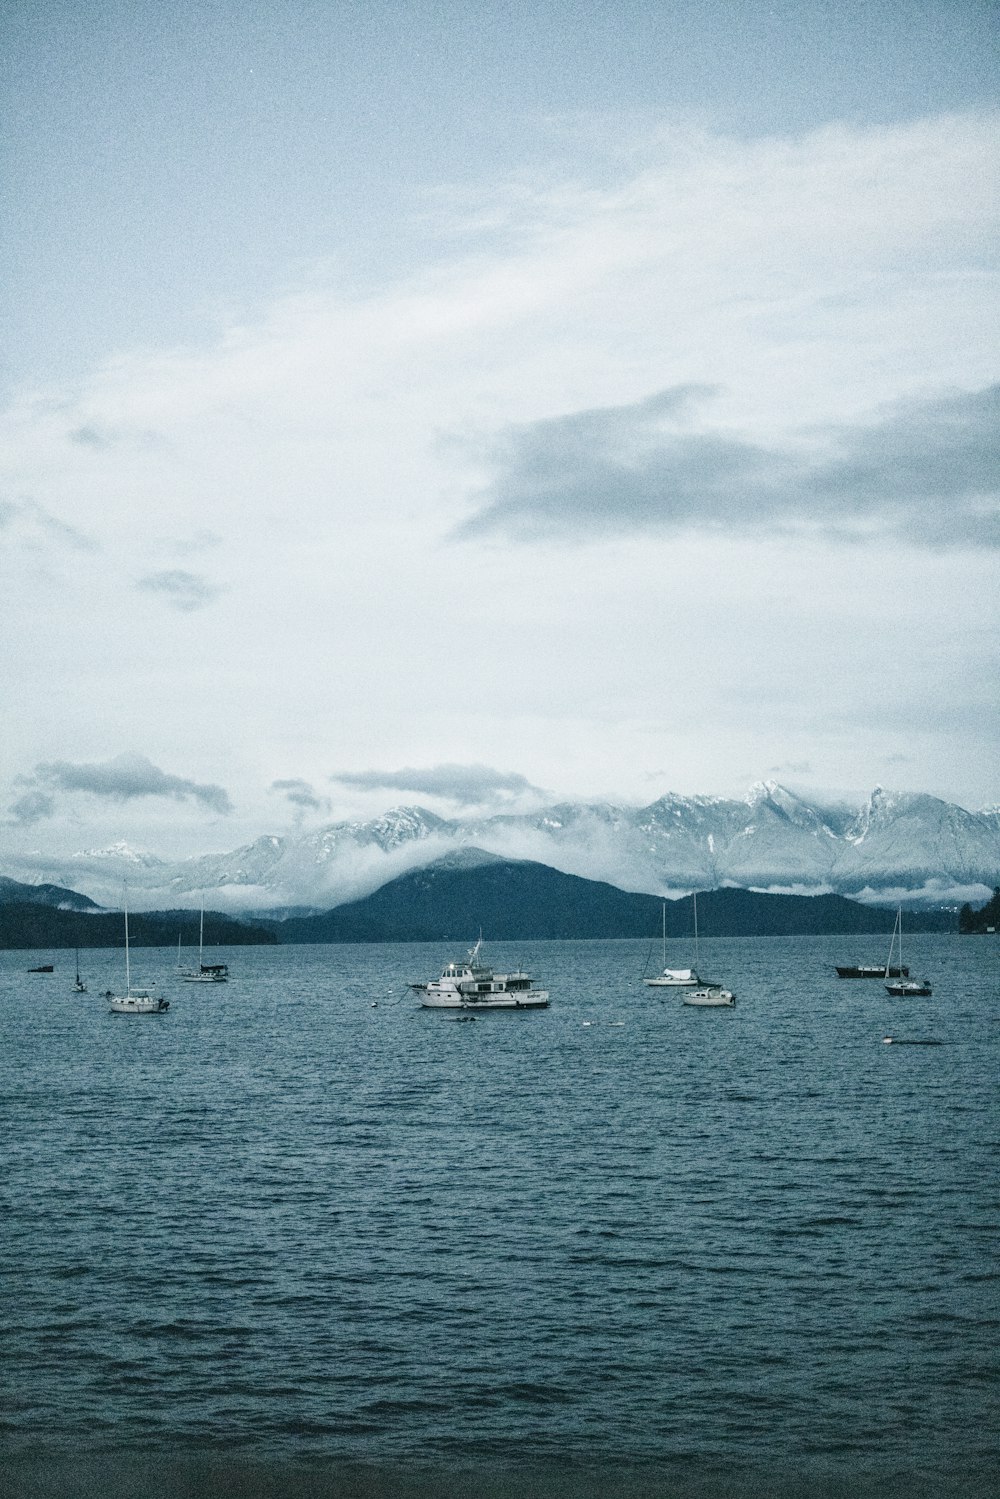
[{"left": 0, "top": 0, "right": 1000, "bottom": 869}]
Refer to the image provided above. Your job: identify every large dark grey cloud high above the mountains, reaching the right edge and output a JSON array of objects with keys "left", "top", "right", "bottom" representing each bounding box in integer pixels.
[{"left": 456, "top": 385, "right": 1000, "bottom": 547}]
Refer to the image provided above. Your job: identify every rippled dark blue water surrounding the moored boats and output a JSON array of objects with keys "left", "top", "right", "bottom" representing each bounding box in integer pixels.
[{"left": 0, "top": 937, "right": 1000, "bottom": 1499}]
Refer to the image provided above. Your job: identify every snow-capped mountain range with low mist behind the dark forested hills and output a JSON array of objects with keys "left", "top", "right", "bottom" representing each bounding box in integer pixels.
[{"left": 13, "top": 781, "right": 1000, "bottom": 911}]
